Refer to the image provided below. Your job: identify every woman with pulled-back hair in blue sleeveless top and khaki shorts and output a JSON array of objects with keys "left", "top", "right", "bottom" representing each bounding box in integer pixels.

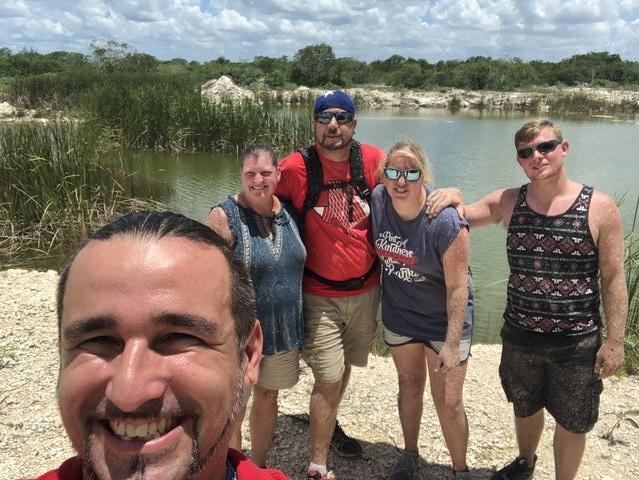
[{"left": 206, "top": 145, "right": 306, "bottom": 466}]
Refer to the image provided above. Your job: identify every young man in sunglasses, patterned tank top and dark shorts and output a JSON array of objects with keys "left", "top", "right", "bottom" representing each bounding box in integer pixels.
[{"left": 427, "top": 120, "right": 628, "bottom": 480}]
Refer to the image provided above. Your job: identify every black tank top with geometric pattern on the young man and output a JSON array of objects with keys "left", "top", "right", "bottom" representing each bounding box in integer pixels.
[{"left": 504, "top": 185, "right": 601, "bottom": 335}]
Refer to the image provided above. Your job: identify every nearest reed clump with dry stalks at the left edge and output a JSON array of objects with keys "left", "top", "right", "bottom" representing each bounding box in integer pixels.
[{"left": 0, "top": 122, "right": 169, "bottom": 266}]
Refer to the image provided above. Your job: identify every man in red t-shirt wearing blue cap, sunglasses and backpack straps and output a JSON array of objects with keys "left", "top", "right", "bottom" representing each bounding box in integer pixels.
[{"left": 276, "top": 90, "right": 384, "bottom": 479}]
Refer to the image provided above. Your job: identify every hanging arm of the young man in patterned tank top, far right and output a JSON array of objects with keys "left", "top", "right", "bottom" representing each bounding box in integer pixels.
[{"left": 589, "top": 192, "right": 628, "bottom": 378}]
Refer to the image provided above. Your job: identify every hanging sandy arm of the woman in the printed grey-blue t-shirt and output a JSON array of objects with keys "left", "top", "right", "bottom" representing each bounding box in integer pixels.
[{"left": 437, "top": 228, "right": 470, "bottom": 373}]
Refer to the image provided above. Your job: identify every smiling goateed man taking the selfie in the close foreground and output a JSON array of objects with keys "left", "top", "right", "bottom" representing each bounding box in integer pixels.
[{"left": 30, "top": 212, "right": 287, "bottom": 480}]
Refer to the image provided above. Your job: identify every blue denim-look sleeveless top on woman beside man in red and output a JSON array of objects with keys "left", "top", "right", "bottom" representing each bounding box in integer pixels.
[{"left": 219, "top": 197, "right": 306, "bottom": 355}]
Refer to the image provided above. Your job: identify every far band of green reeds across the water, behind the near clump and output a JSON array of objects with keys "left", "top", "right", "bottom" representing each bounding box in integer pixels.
[{"left": 10, "top": 69, "right": 312, "bottom": 152}]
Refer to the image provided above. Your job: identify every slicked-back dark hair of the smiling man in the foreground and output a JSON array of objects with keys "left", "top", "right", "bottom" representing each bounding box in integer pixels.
[{"left": 57, "top": 211, "right": 256, "bottom": 352}]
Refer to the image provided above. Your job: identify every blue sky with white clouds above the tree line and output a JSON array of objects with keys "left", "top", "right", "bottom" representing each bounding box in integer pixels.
[{"left": 0, "top": 0, "right": 639, "bottom": 62}]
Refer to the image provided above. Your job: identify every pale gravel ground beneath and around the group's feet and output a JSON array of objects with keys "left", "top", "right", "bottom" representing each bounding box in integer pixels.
[{"left": 0, "top": 270, "right": 639, "bottom": 480}]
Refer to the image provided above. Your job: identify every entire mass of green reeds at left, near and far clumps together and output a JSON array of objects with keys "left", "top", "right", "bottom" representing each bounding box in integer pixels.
[{"left": 0, "top": 70, "right": 312, "bottom": 265}]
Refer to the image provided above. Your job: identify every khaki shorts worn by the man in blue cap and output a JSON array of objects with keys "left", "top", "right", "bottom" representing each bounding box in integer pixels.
[{"left": 302, "top": 287, "right": 379, "bottom": 383}]
